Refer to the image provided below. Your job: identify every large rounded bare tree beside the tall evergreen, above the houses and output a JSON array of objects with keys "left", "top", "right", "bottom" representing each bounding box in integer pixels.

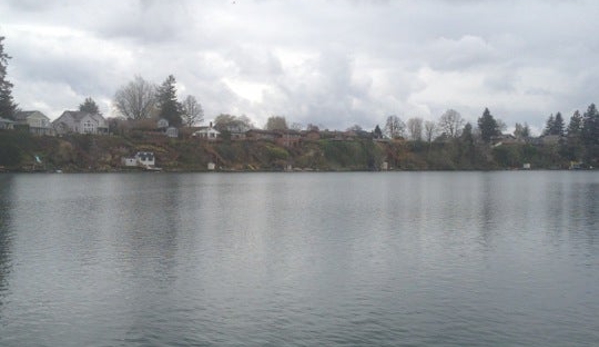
[{"left": 114, "top": 76, "right": 156, "bottom": 119}]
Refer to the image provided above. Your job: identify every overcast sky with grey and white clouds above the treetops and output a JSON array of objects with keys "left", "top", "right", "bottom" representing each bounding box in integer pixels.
[{"left": 0, "top": 0, "right": 599, "bottom": 132}]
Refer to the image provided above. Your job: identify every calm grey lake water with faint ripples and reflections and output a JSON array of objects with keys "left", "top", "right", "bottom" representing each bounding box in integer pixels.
[{"left": 0, "top": 171, "right": 599, "bottom": 347}]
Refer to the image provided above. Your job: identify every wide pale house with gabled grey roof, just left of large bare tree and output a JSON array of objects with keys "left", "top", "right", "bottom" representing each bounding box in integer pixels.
[{"left": 52, "top": 111, "right": 108, "bottom": 134}]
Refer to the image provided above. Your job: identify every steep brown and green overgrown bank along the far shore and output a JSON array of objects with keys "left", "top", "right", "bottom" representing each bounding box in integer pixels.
[{"left": 0, "top": 131, "right": 570, "bottom": 172}]
